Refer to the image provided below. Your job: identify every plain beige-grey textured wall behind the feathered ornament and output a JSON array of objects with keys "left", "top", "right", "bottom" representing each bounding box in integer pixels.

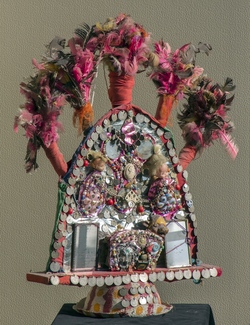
[{"left": 0, "top": 0, "right": 250, "bottom": 325}]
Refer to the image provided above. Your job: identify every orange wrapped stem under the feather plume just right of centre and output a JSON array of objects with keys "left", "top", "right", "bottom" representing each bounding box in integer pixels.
[{"left": 155, "top": 94, "right": 177, "bottom": 127}]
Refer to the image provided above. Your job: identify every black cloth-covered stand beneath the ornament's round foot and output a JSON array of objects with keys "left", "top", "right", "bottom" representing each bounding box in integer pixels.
[{"left": 51, "top": 304, "right": 215, "bottom": 325}]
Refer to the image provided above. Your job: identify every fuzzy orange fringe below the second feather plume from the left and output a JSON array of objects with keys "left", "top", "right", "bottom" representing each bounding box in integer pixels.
[{"left": 73, "top": 102, "right": 94, "bottom": 135}]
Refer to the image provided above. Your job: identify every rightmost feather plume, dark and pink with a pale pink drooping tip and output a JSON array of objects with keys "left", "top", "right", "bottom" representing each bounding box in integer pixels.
[{"left": 178, "top": 76, "right": 238, "bottom": 159}]
